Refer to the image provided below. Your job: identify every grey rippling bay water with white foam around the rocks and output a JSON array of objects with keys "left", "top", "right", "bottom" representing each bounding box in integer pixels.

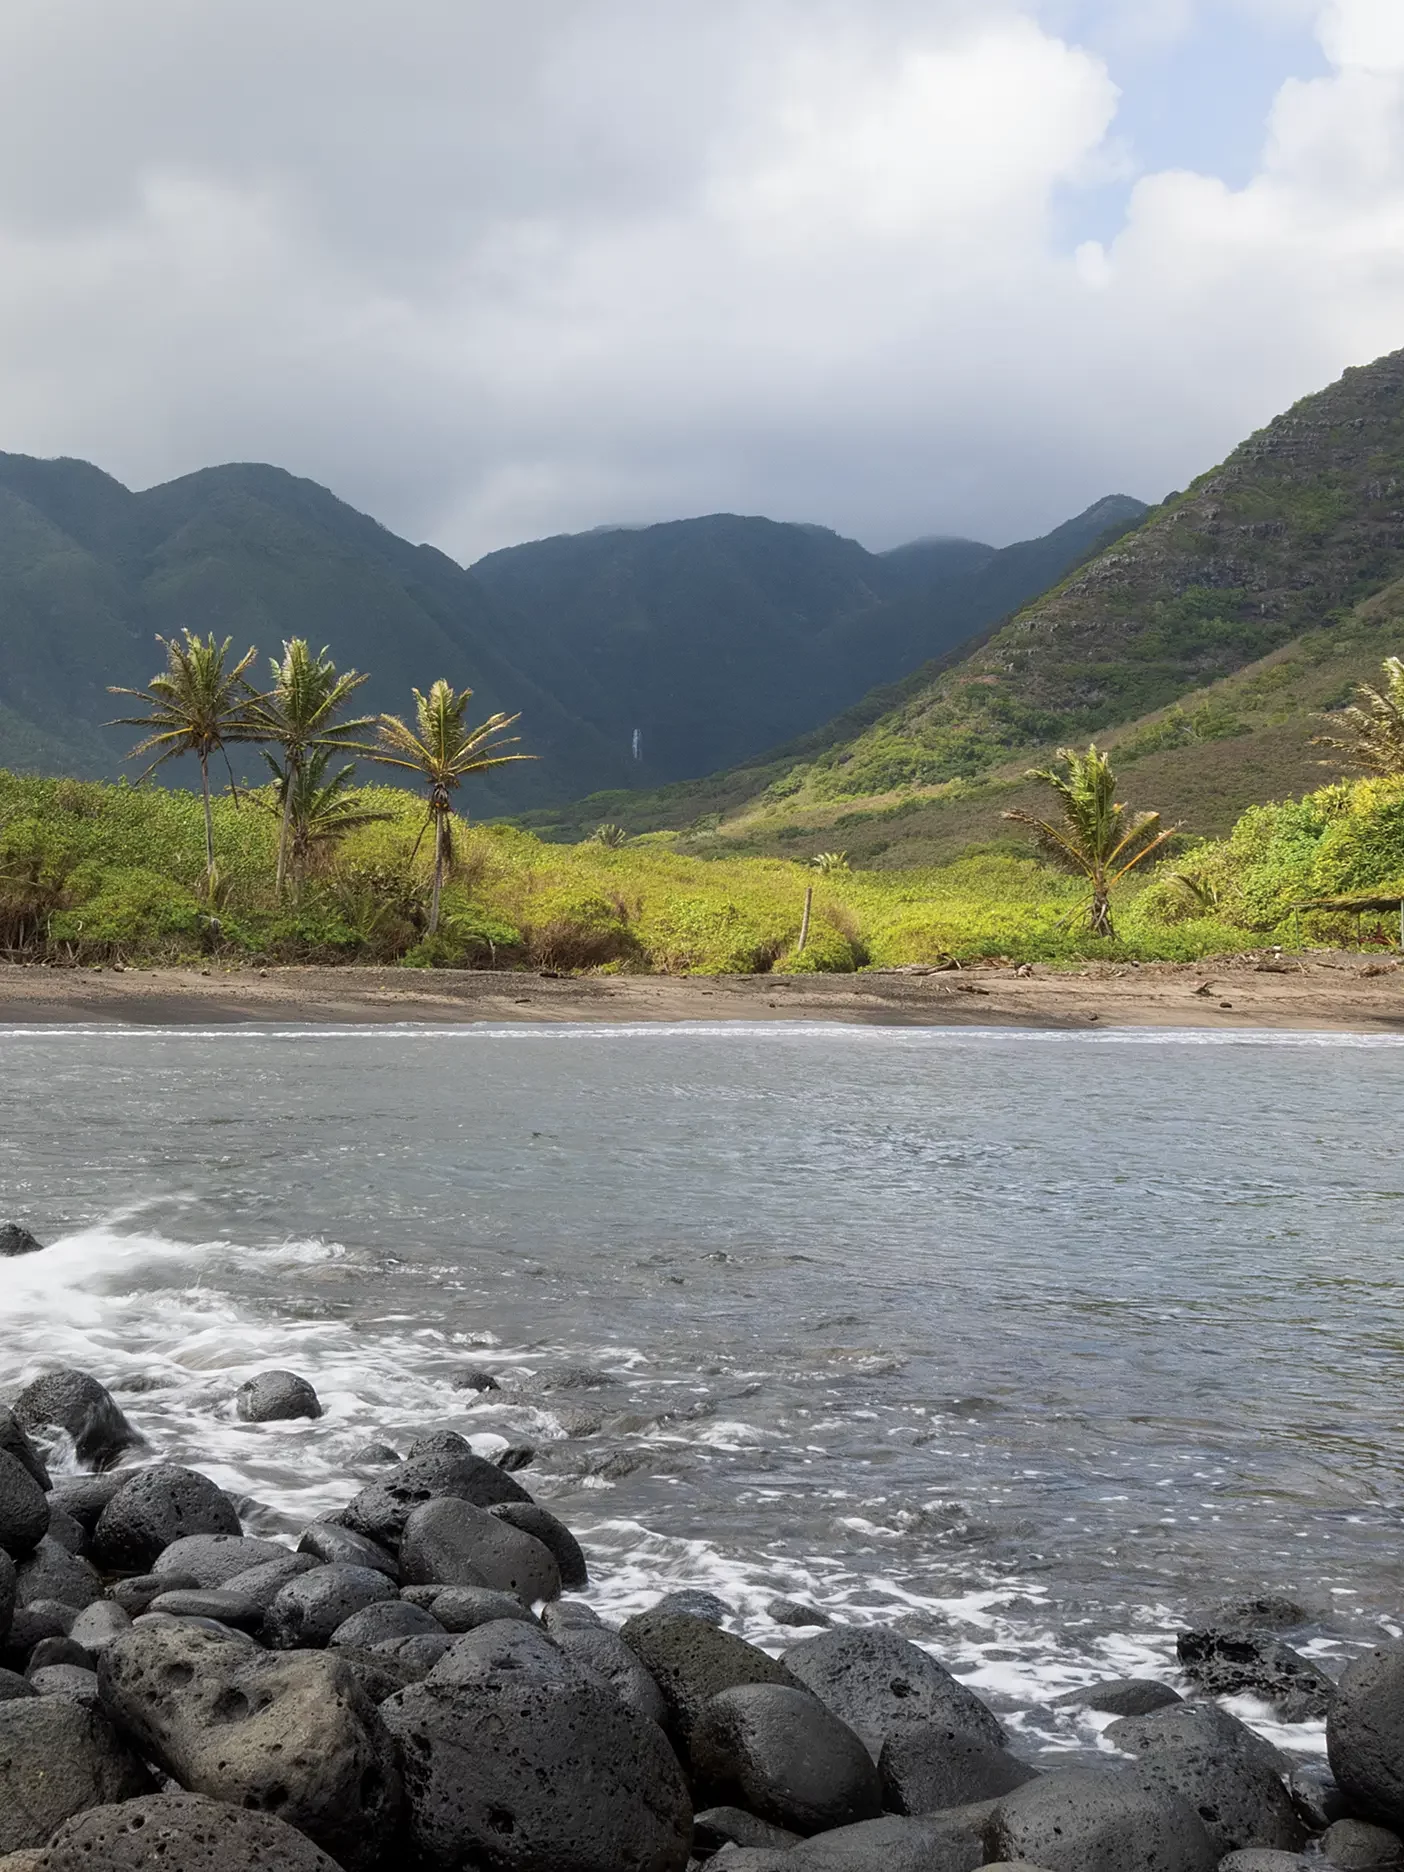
[{"left": 0, "top": 1024, "right": 1404, "bottom": 1754}]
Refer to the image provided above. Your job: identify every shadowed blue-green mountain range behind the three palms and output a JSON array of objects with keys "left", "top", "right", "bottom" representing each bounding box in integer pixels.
[{"left": 0, "top": 455, "right": 1142, "bottom": 811}]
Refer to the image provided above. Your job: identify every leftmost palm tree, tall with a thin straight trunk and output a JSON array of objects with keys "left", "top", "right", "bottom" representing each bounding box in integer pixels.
[{"left": 110, "top": 631, "right": 264, "bottom": 891}]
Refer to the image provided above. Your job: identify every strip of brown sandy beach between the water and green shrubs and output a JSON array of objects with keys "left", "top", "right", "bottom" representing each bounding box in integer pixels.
[{"left": 0, "top": 953, "right": 1404, "bottom": 1033}]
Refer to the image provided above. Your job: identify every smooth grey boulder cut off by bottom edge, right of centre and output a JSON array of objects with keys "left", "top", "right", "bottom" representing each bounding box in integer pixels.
[{"left": 987, "top": 1765, "right": 1221, "bottom": 1872}]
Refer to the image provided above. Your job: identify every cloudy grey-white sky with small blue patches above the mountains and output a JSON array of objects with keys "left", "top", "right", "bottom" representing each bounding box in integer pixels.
[{"left": 0, "top": 0, "right": 1404, "bottom": 560}]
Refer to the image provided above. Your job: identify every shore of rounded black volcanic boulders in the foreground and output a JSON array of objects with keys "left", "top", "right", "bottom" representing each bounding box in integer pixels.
[{"left": 0, "top": 1226, "right": 1404, "bottom": 1872}]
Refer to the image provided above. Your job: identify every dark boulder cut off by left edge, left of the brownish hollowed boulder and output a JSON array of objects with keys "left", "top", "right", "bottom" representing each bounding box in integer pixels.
[{"left": 0, "top": 1696, "right": 152, "bottom": 1853}]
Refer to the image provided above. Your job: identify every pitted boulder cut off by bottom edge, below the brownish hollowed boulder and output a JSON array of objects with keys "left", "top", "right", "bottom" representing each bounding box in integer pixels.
[{"left": 43, "top": 1793, "right": 337, "bottom": 1872}]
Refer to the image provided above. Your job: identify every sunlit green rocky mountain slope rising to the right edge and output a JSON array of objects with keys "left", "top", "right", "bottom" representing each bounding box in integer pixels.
[{"left": 527, "top": 352, "right": 1404, "bottom": 861}]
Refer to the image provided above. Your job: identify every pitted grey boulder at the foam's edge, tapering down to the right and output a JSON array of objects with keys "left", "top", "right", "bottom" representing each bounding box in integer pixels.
[{"left": 784, "top": 1625, "right": 1003, "bottom": 1754}]
